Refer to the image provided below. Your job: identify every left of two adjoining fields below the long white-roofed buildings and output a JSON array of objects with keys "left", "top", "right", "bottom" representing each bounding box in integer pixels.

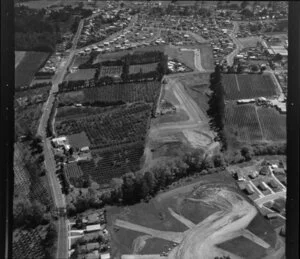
[{"left": 225, "top": 104, "right": 263, "bottom": 142}]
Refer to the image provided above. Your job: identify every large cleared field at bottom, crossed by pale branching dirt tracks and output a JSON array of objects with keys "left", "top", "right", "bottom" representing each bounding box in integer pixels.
[{"left": 107, "top": 174, "right": 276, "bottom": 259}]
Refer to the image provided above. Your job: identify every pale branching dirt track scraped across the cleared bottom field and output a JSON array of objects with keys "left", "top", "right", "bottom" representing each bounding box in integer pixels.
[{"left": 115, "top": 187, "right": 270, "bottom": 259}]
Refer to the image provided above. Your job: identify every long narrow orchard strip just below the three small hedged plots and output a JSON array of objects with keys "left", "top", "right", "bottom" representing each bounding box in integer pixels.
[{"left": 59, "top": 81, "right": 160, "bottom": 108}]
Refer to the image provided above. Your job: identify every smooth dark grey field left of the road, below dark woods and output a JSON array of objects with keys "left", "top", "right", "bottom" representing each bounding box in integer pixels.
[{"left": 15, "top": 51, "right": 49, "bottom": 88}]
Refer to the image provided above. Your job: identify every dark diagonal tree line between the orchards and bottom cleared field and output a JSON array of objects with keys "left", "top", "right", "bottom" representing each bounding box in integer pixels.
[{"left": 67, "top": 141, "right": 286, "bottom": 216}]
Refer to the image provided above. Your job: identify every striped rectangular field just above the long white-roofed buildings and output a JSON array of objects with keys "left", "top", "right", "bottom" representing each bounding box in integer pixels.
[{"left": 222, "top": 74, "right": 276, "bottom": 100}]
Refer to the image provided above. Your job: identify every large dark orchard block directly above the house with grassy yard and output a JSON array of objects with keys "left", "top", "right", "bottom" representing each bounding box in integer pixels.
[{"left": 56, "top": 103, "right": 151, "bottom": 149}]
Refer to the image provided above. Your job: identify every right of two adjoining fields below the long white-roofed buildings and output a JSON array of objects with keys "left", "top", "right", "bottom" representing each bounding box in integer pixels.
[{"left": 257, "top": 108, "right": 287, "bottom": 141}]
